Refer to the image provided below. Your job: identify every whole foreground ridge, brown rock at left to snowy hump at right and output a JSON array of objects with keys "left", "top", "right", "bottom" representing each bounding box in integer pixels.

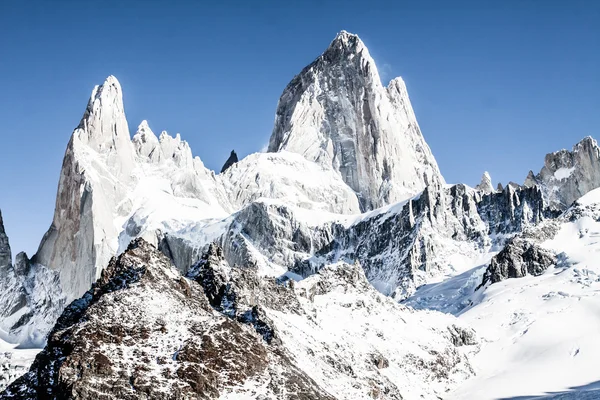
[{"left": 2, "top": 239, "right": 478, "bottom": 399}]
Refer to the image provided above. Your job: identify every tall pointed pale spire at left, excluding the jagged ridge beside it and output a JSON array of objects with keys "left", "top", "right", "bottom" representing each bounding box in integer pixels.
[{"left": 33, "top": 76, "right": 134, "bottom": 298}]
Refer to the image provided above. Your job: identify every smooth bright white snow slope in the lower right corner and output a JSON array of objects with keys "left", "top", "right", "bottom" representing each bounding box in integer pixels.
[{"left": 408, "top": 189, "right": 600, "bottom": 400}]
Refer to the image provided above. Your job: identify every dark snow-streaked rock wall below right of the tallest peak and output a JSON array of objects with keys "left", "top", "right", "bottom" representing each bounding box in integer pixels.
[{"left": 292, "top": 185, "right": 549, "bottom": 300}]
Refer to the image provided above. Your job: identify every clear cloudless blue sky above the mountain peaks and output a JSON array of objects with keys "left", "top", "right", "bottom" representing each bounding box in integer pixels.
[{"left": 0, "top": 0, "right": 600, "bottom": 255}]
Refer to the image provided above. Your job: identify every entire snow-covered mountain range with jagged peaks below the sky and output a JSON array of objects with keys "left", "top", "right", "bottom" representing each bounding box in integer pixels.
[{"left": 0, "top": 32, "right": 600, "bottom": 399}]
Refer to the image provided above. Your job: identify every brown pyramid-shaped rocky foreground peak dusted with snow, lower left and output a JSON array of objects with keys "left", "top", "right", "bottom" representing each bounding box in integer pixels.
[{"left": 3, "top": 239, "right": 331, "bottom": 399}]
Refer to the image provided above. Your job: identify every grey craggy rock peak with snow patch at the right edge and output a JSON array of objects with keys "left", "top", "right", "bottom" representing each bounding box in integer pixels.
[{"left": 526, "top": 136, "right": 600, "bottom": 211}]
